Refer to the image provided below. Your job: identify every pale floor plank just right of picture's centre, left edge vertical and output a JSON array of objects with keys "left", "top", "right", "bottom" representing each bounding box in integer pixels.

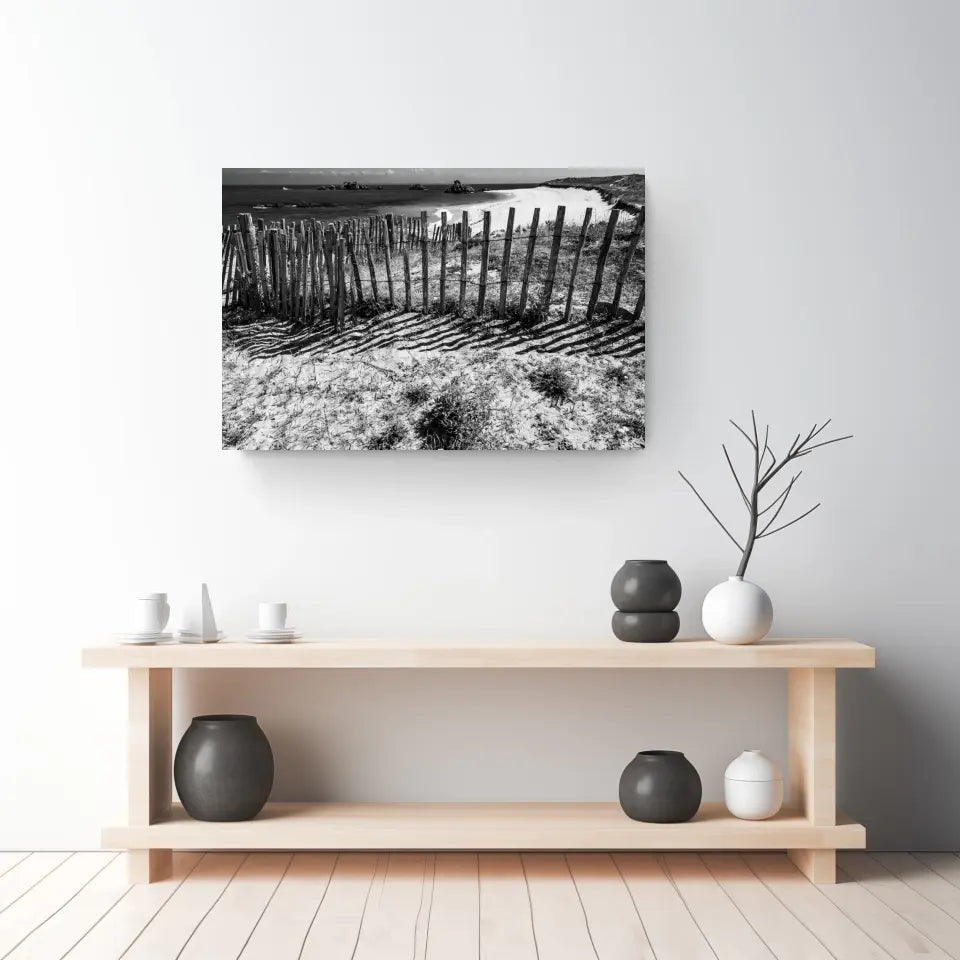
[{"left": 479, "top": 853, "right": 537, "bottom": 960}]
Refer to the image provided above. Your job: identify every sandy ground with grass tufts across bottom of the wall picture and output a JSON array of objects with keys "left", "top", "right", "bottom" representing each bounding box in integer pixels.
[{"left": 223, "top": 346, "right": 645, "bottom": 450}]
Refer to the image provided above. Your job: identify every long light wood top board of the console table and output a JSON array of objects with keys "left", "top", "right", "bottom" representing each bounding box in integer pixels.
[{"left": 82, "top": 637, "right": 875, "bottom": 670}]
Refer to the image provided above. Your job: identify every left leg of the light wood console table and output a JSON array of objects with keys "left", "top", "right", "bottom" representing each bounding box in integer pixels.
[{"left": 127, "top": 667, "right": 173, "bottom": 883}]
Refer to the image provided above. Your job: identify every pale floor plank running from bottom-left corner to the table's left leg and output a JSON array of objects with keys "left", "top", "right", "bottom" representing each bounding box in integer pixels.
[{"left": 4, "top": 854, "right": 130, "bottom": 960}]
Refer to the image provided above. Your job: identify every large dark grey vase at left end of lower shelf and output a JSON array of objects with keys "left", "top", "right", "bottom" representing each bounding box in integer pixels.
[{"left": 173, "top": 713, "right": 273, "bottom": 820}]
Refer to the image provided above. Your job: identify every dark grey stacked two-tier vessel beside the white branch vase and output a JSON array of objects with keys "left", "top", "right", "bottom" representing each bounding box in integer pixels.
[{"left": 610, "top": 560, "right": 681, "bottom": 643}]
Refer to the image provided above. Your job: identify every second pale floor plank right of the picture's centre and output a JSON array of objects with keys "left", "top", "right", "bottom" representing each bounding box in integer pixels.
[{"left": 520, "top": 853, "right": 597, "bottom": 960}]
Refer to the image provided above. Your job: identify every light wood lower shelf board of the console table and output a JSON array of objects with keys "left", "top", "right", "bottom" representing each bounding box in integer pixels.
[{"left": 102, "top": 803, "right": 866, "bottom": 850}]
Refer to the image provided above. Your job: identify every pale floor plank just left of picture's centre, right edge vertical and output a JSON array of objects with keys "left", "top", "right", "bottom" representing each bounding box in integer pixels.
[{"left": 425, "top": 853, "right": 480, "bottom": 960}]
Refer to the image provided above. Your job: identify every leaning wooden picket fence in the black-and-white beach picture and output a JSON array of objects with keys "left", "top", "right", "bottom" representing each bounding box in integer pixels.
[{"left": 221, "top": 205, "right": 645, "bottom": 331}]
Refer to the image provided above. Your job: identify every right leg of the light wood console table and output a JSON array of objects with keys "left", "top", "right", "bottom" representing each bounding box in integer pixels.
[{"left": 787, "top": 667, "right": 837, "bottom": 883}]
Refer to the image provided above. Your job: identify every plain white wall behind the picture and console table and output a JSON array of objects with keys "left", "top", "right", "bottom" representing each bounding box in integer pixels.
[{"left": 0, "top": 0, "right": 960, "bottom": 849}]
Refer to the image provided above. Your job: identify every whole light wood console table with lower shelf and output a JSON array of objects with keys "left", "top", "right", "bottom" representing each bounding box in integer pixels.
[{"left": 83, "top": 638, "right": 875, "bottom": 883}]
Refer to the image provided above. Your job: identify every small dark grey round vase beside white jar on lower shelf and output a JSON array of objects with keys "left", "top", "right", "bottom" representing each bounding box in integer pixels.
[{"left": 620, "top": 750, "right": 703, "bottom": 823}]
